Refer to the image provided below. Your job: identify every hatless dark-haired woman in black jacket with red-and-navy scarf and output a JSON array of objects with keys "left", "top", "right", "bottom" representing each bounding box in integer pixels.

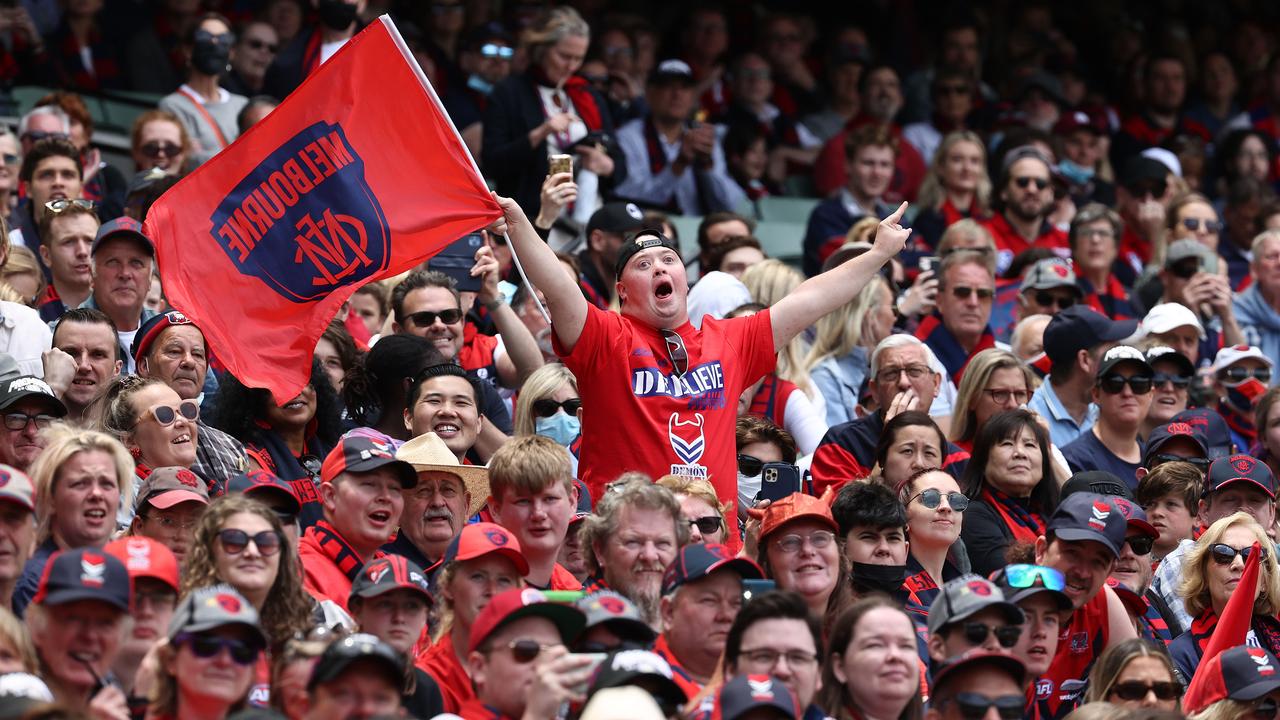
[{"left": 960, "top": 410, "right": 1057, "bottom": 575}]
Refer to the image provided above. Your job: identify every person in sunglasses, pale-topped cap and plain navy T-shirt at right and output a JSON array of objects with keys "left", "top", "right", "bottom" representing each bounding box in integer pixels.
[{"left": 1061, "top": 345, "right": 1155, "bottom": 489}]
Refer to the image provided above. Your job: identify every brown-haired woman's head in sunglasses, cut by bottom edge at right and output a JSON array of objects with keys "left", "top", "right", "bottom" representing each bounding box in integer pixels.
[{"left": 1084, "top": 638, "right": 1183, "bottom": 712}]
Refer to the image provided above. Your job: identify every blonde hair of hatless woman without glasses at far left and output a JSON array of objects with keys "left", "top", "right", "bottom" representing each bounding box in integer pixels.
[{"left": 31, "top": 423, "right": 133, "bottom": 543}]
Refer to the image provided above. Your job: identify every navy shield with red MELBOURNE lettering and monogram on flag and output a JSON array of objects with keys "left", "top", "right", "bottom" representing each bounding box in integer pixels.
[{"left": 210, "top": 122, "right": 390, "bottom": 302}]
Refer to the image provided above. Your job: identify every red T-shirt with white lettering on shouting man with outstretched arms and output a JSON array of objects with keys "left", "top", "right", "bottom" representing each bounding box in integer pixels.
[{"left": 556, "top": 306, "right": 777, "bottom": 537}]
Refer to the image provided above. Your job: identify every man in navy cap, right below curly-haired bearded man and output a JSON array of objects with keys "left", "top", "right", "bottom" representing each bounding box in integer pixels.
[{"left": 653, "top": 543, "right": 764, "bottom": 697}]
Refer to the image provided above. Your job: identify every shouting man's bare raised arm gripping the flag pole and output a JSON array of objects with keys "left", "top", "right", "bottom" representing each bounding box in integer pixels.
[{"left": 489, "top": 193, "right": 586, "bottom": 350}]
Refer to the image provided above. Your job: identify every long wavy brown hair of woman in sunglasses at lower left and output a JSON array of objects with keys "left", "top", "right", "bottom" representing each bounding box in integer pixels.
[{"left": 182, "top": 495, "right": 312, "bottom": 647}]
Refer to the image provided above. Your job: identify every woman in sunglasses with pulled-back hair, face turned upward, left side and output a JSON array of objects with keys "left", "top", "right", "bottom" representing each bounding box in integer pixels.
[{"left": 100, "top": 375, "right": 200, "bottom": 525}]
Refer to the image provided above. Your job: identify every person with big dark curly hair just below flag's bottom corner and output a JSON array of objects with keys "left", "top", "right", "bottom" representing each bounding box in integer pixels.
[{"left": 214, "top": 360, "right": 342, "bottom": 530}]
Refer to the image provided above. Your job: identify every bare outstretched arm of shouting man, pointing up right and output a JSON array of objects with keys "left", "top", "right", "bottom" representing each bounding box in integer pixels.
[{"left": 769, "top": 202, "right": 911, "bottom": 347}]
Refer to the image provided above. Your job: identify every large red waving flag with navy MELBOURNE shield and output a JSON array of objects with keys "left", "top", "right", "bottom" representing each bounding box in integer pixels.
[{"left": 146, "top": 15, "right": 502, "bottom": 404}]
